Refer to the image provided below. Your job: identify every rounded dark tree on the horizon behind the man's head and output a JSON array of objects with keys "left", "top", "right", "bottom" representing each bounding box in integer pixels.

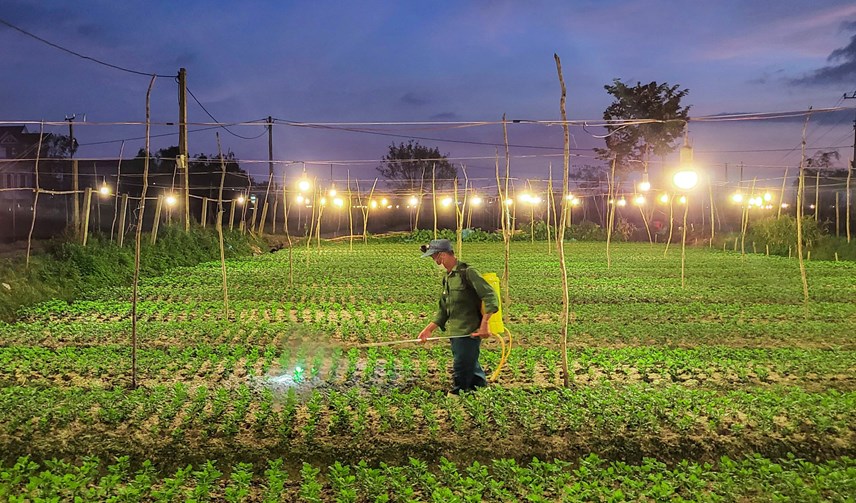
[{"left": 377, "top": 140, "right": 458, "bottom": 192}]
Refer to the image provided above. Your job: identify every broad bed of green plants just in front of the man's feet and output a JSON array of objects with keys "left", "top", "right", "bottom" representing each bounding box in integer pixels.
[{"left": 0, "top": 384, "right": 856, "bottom": 461}]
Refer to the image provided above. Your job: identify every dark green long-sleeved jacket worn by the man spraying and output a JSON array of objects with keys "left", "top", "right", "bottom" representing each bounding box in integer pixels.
[{"left": 434, "top": 262, "right": 499, "bottom": 335}]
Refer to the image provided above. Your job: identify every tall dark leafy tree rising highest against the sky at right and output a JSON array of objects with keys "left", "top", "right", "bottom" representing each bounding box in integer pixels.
[{"left": 595, "top": 79, "right": 690, "bottom": 172}]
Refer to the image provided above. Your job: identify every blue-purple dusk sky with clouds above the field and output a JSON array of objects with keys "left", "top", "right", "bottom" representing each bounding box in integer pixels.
[{"left": 0, "top": 0, "right": 856, "bottom": 193}]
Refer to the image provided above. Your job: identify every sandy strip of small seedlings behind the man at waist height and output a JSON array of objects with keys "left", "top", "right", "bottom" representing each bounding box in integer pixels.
[{"left": 8, "top": 308, "right": 856, "bottom": 350}]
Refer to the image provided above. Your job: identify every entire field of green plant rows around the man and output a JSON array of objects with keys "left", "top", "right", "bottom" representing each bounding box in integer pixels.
[{"left": 0, "top": 242, "right": 856, "bottom": 501}]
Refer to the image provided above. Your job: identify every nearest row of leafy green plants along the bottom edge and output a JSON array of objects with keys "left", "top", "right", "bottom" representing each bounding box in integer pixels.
[{"left": 0, "top": 454, "right": 856, "bottom": 503}]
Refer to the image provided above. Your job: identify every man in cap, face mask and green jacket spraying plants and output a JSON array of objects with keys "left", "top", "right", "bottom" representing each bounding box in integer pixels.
[{"left": 419, "top": 239, "right": 499, "bottom": 395}]
